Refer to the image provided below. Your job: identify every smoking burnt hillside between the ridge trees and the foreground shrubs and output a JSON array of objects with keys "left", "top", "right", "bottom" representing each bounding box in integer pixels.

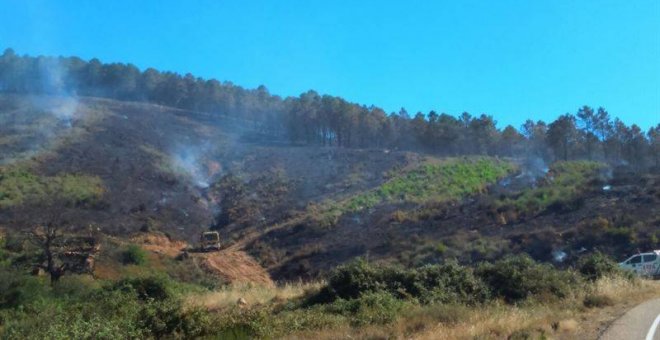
[{"left": 0, "top": 95, "right": 660, "bottom": 280}]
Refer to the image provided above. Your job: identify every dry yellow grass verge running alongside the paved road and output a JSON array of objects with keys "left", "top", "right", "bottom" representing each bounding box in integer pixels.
[{"left": 290, "top": 278, "right": 660, "bottom": 340}]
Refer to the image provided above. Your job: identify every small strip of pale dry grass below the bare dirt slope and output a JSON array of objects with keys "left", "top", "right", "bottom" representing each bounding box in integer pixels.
[{"left": 186, "top": 282, "right": 323, "bottom": 310}]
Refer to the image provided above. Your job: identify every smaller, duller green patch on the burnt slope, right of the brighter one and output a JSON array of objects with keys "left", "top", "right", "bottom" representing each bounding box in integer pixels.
[{"left": 495, "top": 161, "right": 604, "bottom": 215}]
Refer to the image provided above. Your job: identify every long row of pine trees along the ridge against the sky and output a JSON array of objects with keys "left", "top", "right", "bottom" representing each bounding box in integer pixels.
[{"left": 0, "top": 49, "right": 660, "bottom": 171}]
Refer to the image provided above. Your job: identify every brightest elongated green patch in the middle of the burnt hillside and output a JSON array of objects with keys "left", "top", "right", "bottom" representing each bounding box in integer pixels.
[{"left": 348, "top": 157, "right": 515, "bottom": 211}]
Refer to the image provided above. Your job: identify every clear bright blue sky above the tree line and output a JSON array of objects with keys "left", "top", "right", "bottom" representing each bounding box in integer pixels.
[{"left": 0, "top": 0, "right": 660, "bottom": 130}]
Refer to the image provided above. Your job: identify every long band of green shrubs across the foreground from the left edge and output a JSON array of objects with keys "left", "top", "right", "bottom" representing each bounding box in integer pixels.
[{"left": 0, "top": 250, "right": 636, "bottom": 339}]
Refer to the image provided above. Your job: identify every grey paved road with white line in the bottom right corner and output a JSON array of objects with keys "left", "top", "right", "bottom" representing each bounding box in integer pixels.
[{"left": 600, "top": 299, "right": 660, "bottom": 340}]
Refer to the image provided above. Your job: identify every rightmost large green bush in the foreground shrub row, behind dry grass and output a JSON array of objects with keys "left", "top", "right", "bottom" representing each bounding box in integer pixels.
[{"left": 477, "top": 255, "right": 579, "bottom": 303}]
